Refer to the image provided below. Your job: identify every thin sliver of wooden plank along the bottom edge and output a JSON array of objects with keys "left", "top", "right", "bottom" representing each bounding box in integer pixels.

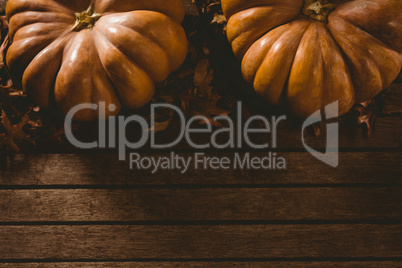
[{"left": 0, "top": 261, "right": 402, "bottom": 268}]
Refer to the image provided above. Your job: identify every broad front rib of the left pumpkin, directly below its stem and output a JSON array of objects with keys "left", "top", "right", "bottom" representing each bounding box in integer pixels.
[{"left": 54, "top": 30, "right": 120, "bottom": 121}]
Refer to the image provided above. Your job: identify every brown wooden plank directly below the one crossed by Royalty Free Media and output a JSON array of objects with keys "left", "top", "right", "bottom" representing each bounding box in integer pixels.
[{"left": 0, "top": 187, "right": 402, "bottom": 223}]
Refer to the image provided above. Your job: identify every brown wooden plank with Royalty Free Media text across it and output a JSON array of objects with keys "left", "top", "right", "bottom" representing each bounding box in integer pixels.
[{"left": 0, "top": 151, "right": 402, "bottom": 187}]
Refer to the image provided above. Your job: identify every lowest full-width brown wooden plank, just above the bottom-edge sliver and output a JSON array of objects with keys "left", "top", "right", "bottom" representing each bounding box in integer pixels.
[{"left": 0, "top": 224, "right": 402, "bottom": 260}]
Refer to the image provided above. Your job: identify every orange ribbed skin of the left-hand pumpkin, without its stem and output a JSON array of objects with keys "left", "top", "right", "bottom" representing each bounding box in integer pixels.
[{"left": 6, "top": 0, "right": 188, "bottom": 121}]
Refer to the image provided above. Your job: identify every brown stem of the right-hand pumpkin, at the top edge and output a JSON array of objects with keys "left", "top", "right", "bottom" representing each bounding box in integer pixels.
[{"left": 302, "top": 0, "right": 335, "bottom": 22}]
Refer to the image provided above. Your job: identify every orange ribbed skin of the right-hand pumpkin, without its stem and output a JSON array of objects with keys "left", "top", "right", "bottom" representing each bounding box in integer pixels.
[{"left": 222, "top": 0, "right": 402, "bottom": 117}]
